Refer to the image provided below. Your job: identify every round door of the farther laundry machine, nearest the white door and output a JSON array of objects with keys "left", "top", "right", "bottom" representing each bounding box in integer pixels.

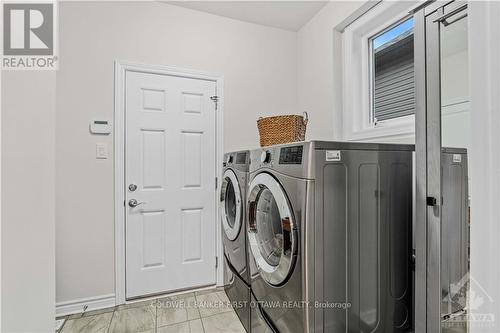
[{"left": 220, "top": 169, "right": 242, "bottom": 240}]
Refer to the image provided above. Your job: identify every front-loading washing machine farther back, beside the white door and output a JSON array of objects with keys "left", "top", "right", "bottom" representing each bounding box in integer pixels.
[{"left": 219, "top": 151, "right": 251, "bottom": 331}]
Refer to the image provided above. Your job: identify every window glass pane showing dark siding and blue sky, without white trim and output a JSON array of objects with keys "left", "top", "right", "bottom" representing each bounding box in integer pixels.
[{"left": 368, "top": 17, "right": 415, "bottom": 125}]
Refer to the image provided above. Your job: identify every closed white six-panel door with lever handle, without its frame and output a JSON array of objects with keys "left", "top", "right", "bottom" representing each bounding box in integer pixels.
[{"left": 125, "top": 71, "right": 216, "bottom": 298}]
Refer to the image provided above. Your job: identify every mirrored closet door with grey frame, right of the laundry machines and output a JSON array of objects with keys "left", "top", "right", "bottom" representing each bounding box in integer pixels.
[{"left": 415, "top": 1, "right": 473, "bottom": 332}]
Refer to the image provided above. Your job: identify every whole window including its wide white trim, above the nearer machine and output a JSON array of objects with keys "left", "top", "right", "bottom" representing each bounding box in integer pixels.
[{"left": 340, "top": 1, "right": 416, "bottom": 143}]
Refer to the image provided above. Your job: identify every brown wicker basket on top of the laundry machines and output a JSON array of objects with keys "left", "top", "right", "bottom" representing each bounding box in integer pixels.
[{"left": 257, "top": 112, "right": 308, "bottom": 147}]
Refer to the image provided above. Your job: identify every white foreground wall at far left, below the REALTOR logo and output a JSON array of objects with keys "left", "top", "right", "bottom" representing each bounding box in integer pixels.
[{"left": 0, "top": 71, "right": 56, "bottom": 333}]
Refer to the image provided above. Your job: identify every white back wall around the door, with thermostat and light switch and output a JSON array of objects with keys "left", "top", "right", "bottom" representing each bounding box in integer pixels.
[{"left": 56, "top": 2, "right": 296, "bottom": 302}]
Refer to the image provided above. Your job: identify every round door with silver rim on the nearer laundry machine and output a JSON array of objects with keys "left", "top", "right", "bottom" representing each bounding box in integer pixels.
[{"left": 248, "top": 173, "right": 297, "bottom": 286}]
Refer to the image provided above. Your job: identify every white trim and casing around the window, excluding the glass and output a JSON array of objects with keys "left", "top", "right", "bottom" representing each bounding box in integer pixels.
[{"left": 342, "top": 1, "right": 416, "bottom": 141}]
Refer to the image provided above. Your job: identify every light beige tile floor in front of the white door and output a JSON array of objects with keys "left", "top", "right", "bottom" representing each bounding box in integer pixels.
[{"left": 59, "top": 288, "right": 245, "bottom": 333}]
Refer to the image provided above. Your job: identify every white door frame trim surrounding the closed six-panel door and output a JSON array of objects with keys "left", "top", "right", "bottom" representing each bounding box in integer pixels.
[{"left": 114, "top": 60, "right": 224, "bottom": 305}]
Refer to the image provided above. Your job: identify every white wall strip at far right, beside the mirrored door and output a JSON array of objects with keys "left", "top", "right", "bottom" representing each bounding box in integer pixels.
[{"left": 468, "top": 1, "right": 500, "bottom": 333}]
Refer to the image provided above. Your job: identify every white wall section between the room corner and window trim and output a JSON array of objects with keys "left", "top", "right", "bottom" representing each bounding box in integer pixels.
[{"left": 297, "top": 1, "right": 365, "bottom": 140}]
